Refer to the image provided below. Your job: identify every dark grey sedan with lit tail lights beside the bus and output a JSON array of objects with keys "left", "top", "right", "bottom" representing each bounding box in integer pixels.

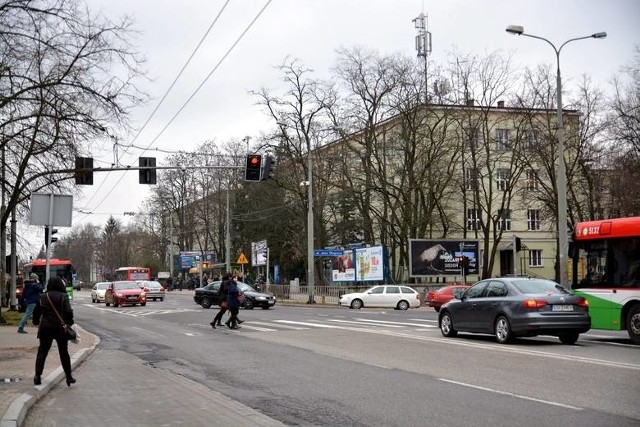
[{"left": 438, "top": 277, "right": 591, "bottom": 344}]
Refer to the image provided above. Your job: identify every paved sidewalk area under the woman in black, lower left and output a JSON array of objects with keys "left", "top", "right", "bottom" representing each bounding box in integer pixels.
[{"left": 0, "top": 302, "right": 284, "bottom": 427}]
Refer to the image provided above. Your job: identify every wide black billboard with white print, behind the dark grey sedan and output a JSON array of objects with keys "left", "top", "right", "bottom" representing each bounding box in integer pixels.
[{"left": 409, "top": 239, "right": 479, "bottom": 277}]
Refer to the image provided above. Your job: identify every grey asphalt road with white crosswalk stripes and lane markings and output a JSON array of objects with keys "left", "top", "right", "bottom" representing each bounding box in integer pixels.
[{"left": 23, "top": 292, "right": 640, "bottom": 427}]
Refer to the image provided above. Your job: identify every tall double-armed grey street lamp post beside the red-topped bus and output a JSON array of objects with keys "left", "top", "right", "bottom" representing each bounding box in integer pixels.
[{"left": 506, "top": 25, "right": 607, "bottom": 285}]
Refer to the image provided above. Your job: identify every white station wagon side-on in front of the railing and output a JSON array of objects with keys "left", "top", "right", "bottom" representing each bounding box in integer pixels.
[{"left": 339, "top": 285, "right": 420, "bottom": 310}]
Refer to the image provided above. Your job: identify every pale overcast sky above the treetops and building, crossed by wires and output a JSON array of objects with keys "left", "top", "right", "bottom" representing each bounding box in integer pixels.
[{"left": 37, "top": 0, "right": 640, "bottom": 254}]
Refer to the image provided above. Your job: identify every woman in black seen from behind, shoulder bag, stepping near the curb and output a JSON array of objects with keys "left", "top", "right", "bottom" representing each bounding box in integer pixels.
[{"left": 33, "top": 276, "right": 76, "bottom": 386}]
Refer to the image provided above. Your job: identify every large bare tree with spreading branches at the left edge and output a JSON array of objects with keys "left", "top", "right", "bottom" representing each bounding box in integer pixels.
[{"left": 0, "top": 0, "right": 142, "bottom": 314}]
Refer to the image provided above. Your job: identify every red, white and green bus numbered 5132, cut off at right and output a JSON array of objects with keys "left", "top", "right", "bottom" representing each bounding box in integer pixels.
[{"left": 571, "top": 217, "right": 640, "bottom": 344}]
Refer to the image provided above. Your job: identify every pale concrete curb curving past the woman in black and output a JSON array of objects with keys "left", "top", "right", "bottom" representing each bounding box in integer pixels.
[{"left": 0, "top": 326, "right": 100, "bottom": 427}]
